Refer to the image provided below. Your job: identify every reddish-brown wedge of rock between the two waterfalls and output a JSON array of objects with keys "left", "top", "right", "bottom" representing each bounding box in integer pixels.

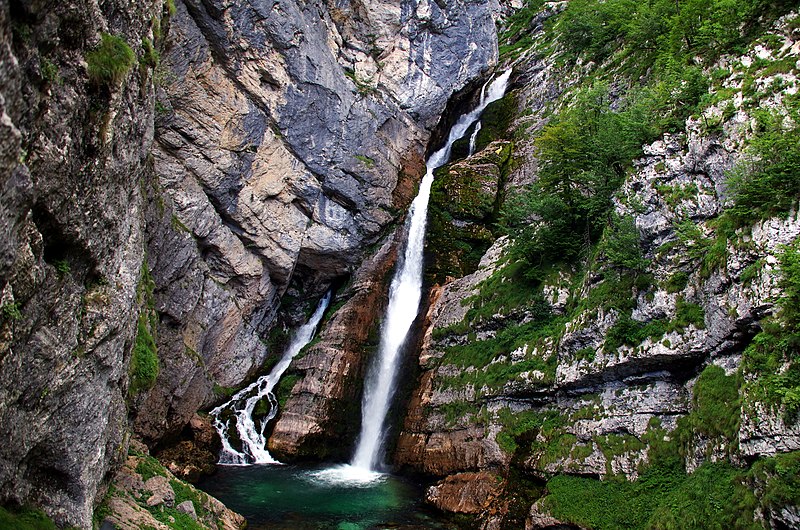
[{"left": 269, "top": 231, "right": 402, "bottom": 460}]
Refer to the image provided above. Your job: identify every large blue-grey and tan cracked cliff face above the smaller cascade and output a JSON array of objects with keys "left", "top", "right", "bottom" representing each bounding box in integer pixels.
[{"left": 136, "top": 0, "right": 497, "bottom": 442}]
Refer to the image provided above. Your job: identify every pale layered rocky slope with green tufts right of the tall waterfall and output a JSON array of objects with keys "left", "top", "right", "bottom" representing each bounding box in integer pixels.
[{"left": 395, "top": 5, "right": 800, "bottom": 528}]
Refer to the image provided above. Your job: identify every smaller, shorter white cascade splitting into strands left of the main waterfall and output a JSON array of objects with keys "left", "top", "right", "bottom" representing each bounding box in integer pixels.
[{"left": 211, "top": 291, "right": 331, "bottom": 465}]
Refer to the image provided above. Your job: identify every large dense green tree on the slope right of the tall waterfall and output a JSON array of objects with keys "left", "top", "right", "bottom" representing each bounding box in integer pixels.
[{"left": 501, "top": 84, "right": 656, "bottom": 280}]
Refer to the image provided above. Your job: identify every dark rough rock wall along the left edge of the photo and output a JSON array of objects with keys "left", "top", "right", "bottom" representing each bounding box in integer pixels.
[{"left": 0, "top": 1, "right": 156, "bottom": 528}]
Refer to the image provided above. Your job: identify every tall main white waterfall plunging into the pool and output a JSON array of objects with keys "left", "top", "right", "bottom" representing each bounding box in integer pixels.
[{"left": 351, "top": 69, "right": 511, "bottom": 470}]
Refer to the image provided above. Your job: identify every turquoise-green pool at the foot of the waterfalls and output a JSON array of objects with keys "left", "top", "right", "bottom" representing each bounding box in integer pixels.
[{"left": 199, "top": 465, "right": 454, "bottom": 530}]
